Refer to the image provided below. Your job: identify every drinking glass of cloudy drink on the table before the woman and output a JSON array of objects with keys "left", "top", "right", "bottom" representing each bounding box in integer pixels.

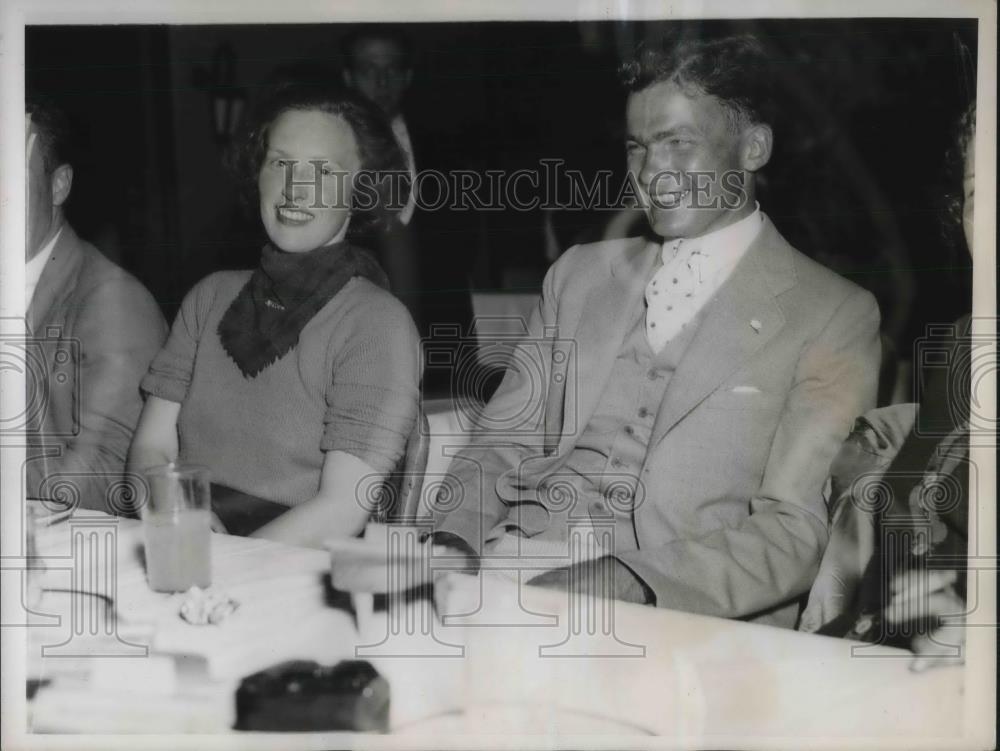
[{"left": 142, "top": 464, "right": 212, "bottom": 592}]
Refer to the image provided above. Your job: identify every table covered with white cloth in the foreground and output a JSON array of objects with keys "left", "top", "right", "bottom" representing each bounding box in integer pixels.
[{"left": 29, "top": 512, "right": 963, "bottom": 747}]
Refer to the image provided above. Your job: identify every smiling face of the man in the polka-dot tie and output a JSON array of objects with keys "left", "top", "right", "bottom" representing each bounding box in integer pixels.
[{"left": 625, "top": 82, "right": 756, "bottom": 240}]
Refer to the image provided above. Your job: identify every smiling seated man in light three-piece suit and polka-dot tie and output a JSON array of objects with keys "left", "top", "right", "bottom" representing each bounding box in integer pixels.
[{"left": 435, "top": 37, "right": 880, "bottom": 627}]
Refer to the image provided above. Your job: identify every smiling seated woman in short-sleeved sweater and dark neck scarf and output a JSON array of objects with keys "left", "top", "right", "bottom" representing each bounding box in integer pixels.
[{"left": 129, "top": 88, "right": 419, "bottom": 546}]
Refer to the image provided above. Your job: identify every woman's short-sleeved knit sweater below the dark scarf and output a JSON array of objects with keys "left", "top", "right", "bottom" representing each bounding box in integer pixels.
[{"left": 142, "top": 271, "right": 420, "bottom": 506}]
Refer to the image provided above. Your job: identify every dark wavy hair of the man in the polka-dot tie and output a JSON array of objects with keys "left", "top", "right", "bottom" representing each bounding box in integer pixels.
[{"left": 619, "top": 35, "right": 777, "bottom": 128}]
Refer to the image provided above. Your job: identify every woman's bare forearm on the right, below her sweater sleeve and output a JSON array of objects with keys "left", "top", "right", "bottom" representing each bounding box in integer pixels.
[{"left": 252, "top": 451, "right": 376, "bottom": 548}]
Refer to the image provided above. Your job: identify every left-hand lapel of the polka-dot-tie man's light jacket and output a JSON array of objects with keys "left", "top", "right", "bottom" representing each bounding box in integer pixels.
[{"left": 560, "top": 239, "right": 660, "bottom": 452}]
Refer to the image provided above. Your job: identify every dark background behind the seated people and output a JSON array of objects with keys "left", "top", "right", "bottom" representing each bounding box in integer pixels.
[{"left": 26, "top": 19, "right": 976, "bottom": 356}]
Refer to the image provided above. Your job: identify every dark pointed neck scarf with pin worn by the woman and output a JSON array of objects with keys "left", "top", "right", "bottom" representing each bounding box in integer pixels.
[{"left": 218, "top": 242, "right": 389, "bottom": 378}]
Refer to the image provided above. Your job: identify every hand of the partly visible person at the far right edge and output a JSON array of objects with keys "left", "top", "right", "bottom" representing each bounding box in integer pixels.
[{"left": 885, "top": 570, "right": 965, "bottom": 672}]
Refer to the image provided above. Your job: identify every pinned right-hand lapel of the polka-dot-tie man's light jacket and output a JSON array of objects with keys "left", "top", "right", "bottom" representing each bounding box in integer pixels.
[{"left": 650, "top": 219, "right": 794, "bottom": 448}]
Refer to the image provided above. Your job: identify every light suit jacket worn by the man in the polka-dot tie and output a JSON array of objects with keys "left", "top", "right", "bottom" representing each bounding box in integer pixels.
[{"left": 435, "top": 218, "right": 880, "bottom": 627}]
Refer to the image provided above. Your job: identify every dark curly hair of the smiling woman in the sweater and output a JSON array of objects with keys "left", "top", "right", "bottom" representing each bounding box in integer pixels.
[{"left": 229, "top": 83, "right": 410, "bottom": 237}]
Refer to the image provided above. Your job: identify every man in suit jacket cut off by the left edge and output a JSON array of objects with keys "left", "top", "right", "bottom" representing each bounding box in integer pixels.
[{"left": 25, "top": 101, "right": 167, "bottom": 511}]
